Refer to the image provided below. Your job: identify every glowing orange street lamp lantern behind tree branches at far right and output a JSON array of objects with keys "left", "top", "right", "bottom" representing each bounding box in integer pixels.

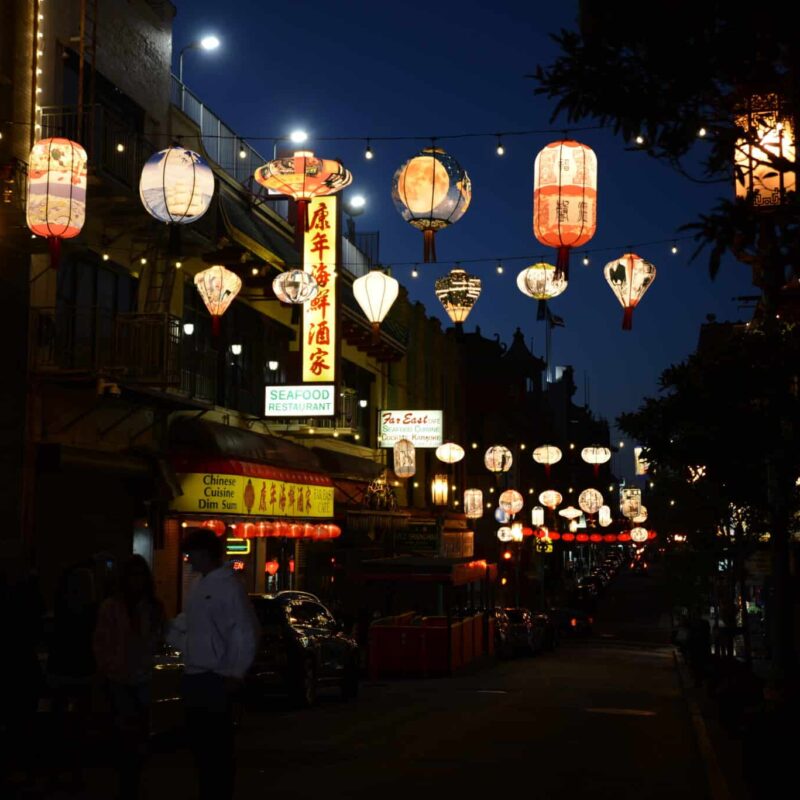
[{"left": 734, "top": 93, "right": 795, "bottom": 210}]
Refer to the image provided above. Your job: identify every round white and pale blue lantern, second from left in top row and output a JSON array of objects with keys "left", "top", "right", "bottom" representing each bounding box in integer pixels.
[{"left": 139, "top": 147, "right": 214, "bottom": 225}]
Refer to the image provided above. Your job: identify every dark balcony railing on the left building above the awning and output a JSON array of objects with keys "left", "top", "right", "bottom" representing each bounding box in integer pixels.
[{"left": 30, "top": 306, "right": 217, "bottom": 403}]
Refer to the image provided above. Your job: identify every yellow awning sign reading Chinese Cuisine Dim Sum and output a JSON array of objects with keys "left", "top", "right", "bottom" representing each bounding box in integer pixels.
[{"left": 170, "top": 472, "right": 333, "bottom": 519}]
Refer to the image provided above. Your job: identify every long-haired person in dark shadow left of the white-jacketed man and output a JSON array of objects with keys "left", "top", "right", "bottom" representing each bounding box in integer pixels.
[{"left": 93, "top": 555, "right": 164, "bottom": 800}]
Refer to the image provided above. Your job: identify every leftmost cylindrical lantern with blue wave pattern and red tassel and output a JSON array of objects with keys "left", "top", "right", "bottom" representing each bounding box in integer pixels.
[{"left": 25, "top": 138, "right": 87, "bottom": 269}]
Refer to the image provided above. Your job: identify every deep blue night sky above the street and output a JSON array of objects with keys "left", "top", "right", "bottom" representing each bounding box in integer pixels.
[{"left": 174, "top": 0, "right": 755, "bottom": 471}]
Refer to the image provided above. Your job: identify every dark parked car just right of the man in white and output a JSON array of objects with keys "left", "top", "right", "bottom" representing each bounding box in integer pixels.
[{"left": 246, "top": 591, "right": 360, "bottom": 707}]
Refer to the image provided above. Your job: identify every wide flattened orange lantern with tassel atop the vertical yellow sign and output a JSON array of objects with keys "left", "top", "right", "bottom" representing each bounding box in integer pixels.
[{"left": 254, "top": 150, "right": 353, "bottom": 247}]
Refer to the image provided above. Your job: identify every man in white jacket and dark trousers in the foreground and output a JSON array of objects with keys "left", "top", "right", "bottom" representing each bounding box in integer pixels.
[{"left": 168, "top": 528, "right": 259, "bottom": 800}]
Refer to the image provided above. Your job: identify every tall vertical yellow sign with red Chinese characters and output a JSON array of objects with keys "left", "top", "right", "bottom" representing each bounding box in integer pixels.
[{"left": 303, "top": 195, "right": 339, "bottom": 383}]
